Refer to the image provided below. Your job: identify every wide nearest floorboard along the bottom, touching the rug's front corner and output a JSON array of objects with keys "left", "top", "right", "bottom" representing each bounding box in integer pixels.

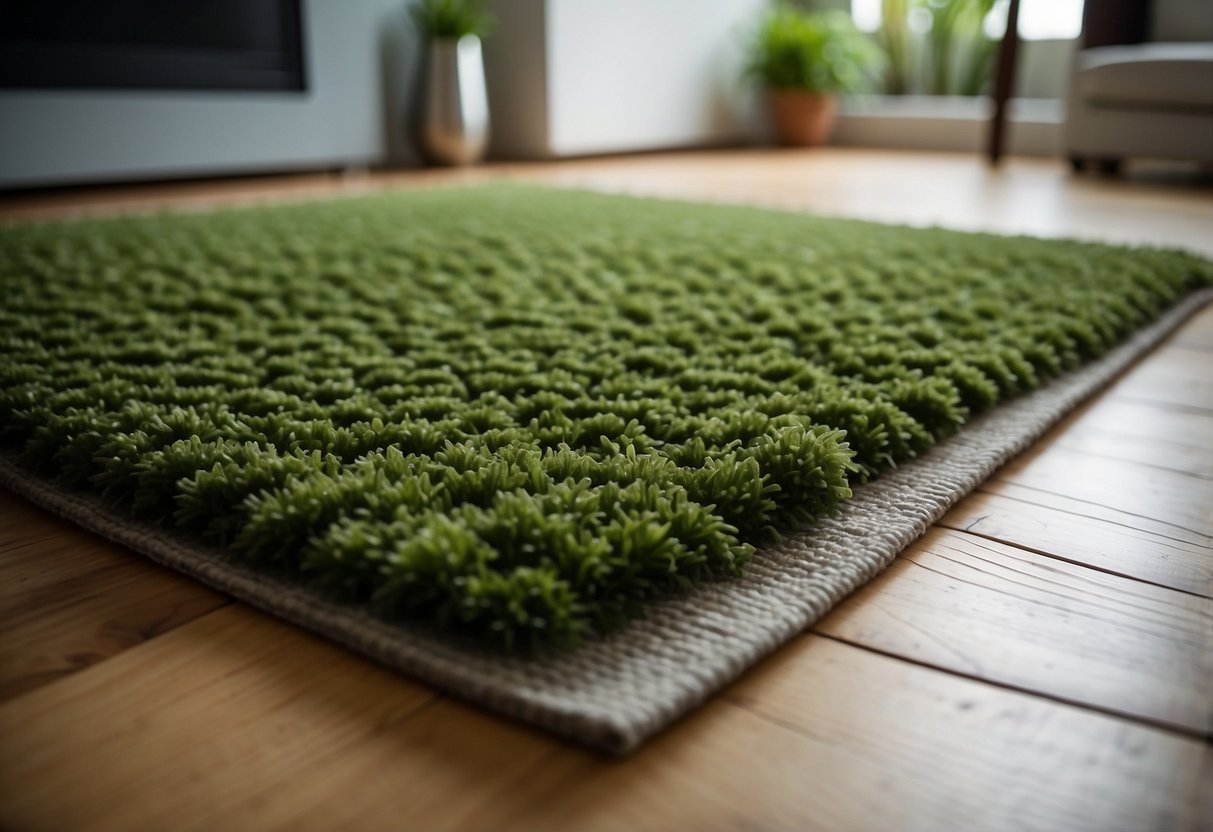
[{"left": 0, "top": 606, "right": 1207, "bottom": 832}]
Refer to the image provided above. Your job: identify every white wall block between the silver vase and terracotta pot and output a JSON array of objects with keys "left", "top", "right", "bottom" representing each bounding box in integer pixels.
[{"left": 486, "top": 0, "right": 767, "bottom": 159}]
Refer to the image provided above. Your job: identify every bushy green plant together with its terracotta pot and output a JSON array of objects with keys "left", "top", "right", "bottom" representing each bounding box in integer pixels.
[{"left": 747, "top": 2, "right": 881, "bottom": 147}]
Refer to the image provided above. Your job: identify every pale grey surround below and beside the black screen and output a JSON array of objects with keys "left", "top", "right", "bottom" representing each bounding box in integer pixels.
[{"left": 0, "top": 0, "right": 418, "bottom": 187}]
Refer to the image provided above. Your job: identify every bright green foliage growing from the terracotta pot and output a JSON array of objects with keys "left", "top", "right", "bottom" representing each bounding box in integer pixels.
[{"left": 746, "top": 2, "right": 881, "bottom": 93}]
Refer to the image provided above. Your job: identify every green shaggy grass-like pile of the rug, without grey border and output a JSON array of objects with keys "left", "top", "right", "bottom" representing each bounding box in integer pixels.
[{"left": 0, "top": 186, "right": 1213, "bottom": 650}]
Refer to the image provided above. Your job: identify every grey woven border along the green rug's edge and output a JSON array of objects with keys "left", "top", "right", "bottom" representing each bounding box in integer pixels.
[{"left": 0, "top": 290, "right": 1213, "bottom": 754}]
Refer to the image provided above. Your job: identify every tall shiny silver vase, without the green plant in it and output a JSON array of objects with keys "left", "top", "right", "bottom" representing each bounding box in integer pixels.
[{"left": 421, "top": 35, "right": 489, "bottom": 165}]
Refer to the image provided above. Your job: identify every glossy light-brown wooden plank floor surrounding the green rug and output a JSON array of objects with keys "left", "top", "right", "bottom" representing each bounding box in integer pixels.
[{"left": 0, "top": 150, "right": 1213, "bottom": 832}]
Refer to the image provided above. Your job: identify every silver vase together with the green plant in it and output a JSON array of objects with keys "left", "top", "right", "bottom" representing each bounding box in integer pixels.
[{"left": 410, "top": 0, "right": 492, "bottom": 165}]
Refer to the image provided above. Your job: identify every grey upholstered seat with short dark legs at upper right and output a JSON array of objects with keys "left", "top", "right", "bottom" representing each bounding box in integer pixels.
[{"left": 1065, "top": 0, "right": 1213, "bottom": 172}]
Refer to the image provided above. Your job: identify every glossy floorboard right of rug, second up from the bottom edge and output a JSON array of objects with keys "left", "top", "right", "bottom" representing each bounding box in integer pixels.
[{"left": 814, "top": 529, "right": 1213, "bottom": 737}]
